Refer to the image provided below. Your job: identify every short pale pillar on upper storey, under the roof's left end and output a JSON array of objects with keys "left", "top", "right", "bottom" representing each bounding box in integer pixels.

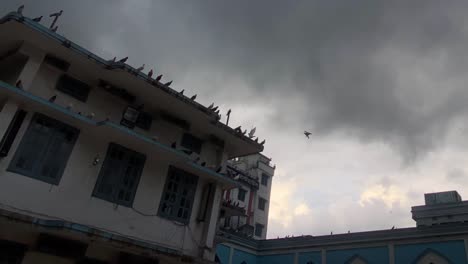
[{"left": 18, "top": 42, "right": 46, "bottom": 90}]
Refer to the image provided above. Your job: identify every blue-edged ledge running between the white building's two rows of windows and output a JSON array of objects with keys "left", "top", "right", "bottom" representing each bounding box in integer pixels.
[{"left": 0, "top": 81, "right": 239, "bottom": 188}]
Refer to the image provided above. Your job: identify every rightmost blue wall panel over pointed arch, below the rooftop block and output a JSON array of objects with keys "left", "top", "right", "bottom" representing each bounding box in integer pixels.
[{"left": 395, "top": 240, "right": 467, "bottom": 264}]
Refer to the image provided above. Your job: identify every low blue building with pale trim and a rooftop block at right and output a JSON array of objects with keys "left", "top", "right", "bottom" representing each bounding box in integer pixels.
[{"left": 217, "top": 191, "right": 468, "bottom": 264}]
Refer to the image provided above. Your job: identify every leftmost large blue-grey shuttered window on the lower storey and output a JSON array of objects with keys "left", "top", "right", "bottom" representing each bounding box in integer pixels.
[{"left": 8, "top": 113, "right": 79, "bottom": 185}]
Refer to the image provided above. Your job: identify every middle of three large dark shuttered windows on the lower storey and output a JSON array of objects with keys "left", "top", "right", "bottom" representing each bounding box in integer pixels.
[{"left": 93, "top": 143, "right": 146, "bottom": 207}]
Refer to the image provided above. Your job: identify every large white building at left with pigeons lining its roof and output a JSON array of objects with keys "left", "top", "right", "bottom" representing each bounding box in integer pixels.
[{"left": 0, "top": 9, "right": 263, "bottom": 264}]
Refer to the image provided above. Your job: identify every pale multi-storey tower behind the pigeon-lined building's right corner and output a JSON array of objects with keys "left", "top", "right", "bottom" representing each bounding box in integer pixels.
[{"left": 219, "top": 153, "right": 275, "bottom": 239}]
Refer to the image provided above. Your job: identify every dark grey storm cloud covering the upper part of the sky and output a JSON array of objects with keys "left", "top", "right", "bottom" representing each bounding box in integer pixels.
[{"left": 0, "top": 0, "right": 468, "bottom": 158}]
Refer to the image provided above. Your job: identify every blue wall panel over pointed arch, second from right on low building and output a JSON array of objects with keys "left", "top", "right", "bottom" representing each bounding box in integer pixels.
[{"left": 327, "top": 247, "right": 388, "bottom": 264}]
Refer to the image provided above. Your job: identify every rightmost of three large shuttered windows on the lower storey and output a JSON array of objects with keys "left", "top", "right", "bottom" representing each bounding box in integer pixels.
[{"left": 158, "top": 166, "right": 198, "bottom": 224}]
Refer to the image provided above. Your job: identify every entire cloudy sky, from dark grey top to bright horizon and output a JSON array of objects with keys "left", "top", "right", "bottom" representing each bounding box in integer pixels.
[{"left": 4, "top": 0, "right": 468, "bottom": 238}]
